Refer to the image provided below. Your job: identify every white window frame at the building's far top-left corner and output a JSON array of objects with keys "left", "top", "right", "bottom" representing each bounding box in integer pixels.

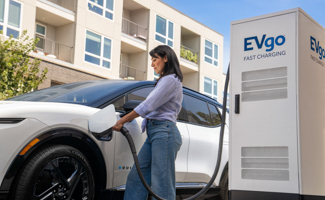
[{"left": 0, "top": 0, "right": 24, "bottom": 39}]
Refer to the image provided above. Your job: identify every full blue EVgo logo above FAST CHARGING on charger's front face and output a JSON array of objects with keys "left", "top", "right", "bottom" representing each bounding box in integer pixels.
[{"left": 244, "top": 34, "right": 286, "bottom": 51}]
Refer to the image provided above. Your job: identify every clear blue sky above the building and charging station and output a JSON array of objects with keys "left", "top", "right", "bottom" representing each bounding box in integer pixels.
[{"left": 161, "top": 0, "right": 325, "bottom": 72}]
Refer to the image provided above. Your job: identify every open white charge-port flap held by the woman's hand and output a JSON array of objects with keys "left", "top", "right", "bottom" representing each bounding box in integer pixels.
[{"left": 88, "top": 104, "right": 117, "bottom": 141}]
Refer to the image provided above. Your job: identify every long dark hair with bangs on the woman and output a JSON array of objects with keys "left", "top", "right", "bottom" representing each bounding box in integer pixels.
[{"left": 149, "top": 45, "right": 183, "bottom": 84}]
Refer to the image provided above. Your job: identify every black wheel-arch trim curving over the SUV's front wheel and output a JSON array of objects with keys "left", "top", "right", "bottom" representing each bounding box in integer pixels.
[{"left": 0, "top": 127, "right": 107, "bottom": 195}]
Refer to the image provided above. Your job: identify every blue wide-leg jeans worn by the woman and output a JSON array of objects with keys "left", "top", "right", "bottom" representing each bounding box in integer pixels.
[{"left": 124, "top": 120, "right": 182, "bottom": 200}]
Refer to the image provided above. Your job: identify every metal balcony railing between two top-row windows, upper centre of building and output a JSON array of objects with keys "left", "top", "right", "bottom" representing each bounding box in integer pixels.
[{"left": 122, "top": 18, "right": 148, "bottom": 41}]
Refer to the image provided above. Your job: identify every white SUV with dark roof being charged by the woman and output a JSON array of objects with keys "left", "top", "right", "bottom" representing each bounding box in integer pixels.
[{"left": 0, "top": 80, "right": 228, "bottom": 200}]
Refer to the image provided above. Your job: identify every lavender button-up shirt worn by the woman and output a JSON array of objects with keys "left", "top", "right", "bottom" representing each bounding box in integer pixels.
[{"left": 134, "top": 74, "right": 183, "bottom": 132}]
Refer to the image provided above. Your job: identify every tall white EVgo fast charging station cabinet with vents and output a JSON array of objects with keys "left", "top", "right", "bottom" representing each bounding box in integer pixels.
[{"left": 229, "top": 8, "right": 325, "bottom": 200}]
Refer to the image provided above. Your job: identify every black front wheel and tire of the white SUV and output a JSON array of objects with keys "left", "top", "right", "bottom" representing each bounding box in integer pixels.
[{"left": 13, "top": 145, "right": 95, "bottom": 200}]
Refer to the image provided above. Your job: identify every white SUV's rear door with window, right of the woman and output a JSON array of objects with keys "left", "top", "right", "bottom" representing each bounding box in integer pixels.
[{"left": 184, "top": 94, "right": 220, "bottom": 183}]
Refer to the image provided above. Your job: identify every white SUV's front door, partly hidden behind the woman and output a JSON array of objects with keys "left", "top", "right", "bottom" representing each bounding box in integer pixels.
[{"left": 113, "top": 87, "right": 189, "bottom": 187}]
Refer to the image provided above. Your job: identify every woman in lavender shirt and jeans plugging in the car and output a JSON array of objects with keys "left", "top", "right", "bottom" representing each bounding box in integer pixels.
[{"left": 113, "top": 45, "right": 183, "bottom": 200}]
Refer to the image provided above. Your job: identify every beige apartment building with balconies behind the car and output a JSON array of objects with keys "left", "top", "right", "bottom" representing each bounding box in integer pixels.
[{"left": 0, "top": 0, "right": 225, "bottom": 101}]
